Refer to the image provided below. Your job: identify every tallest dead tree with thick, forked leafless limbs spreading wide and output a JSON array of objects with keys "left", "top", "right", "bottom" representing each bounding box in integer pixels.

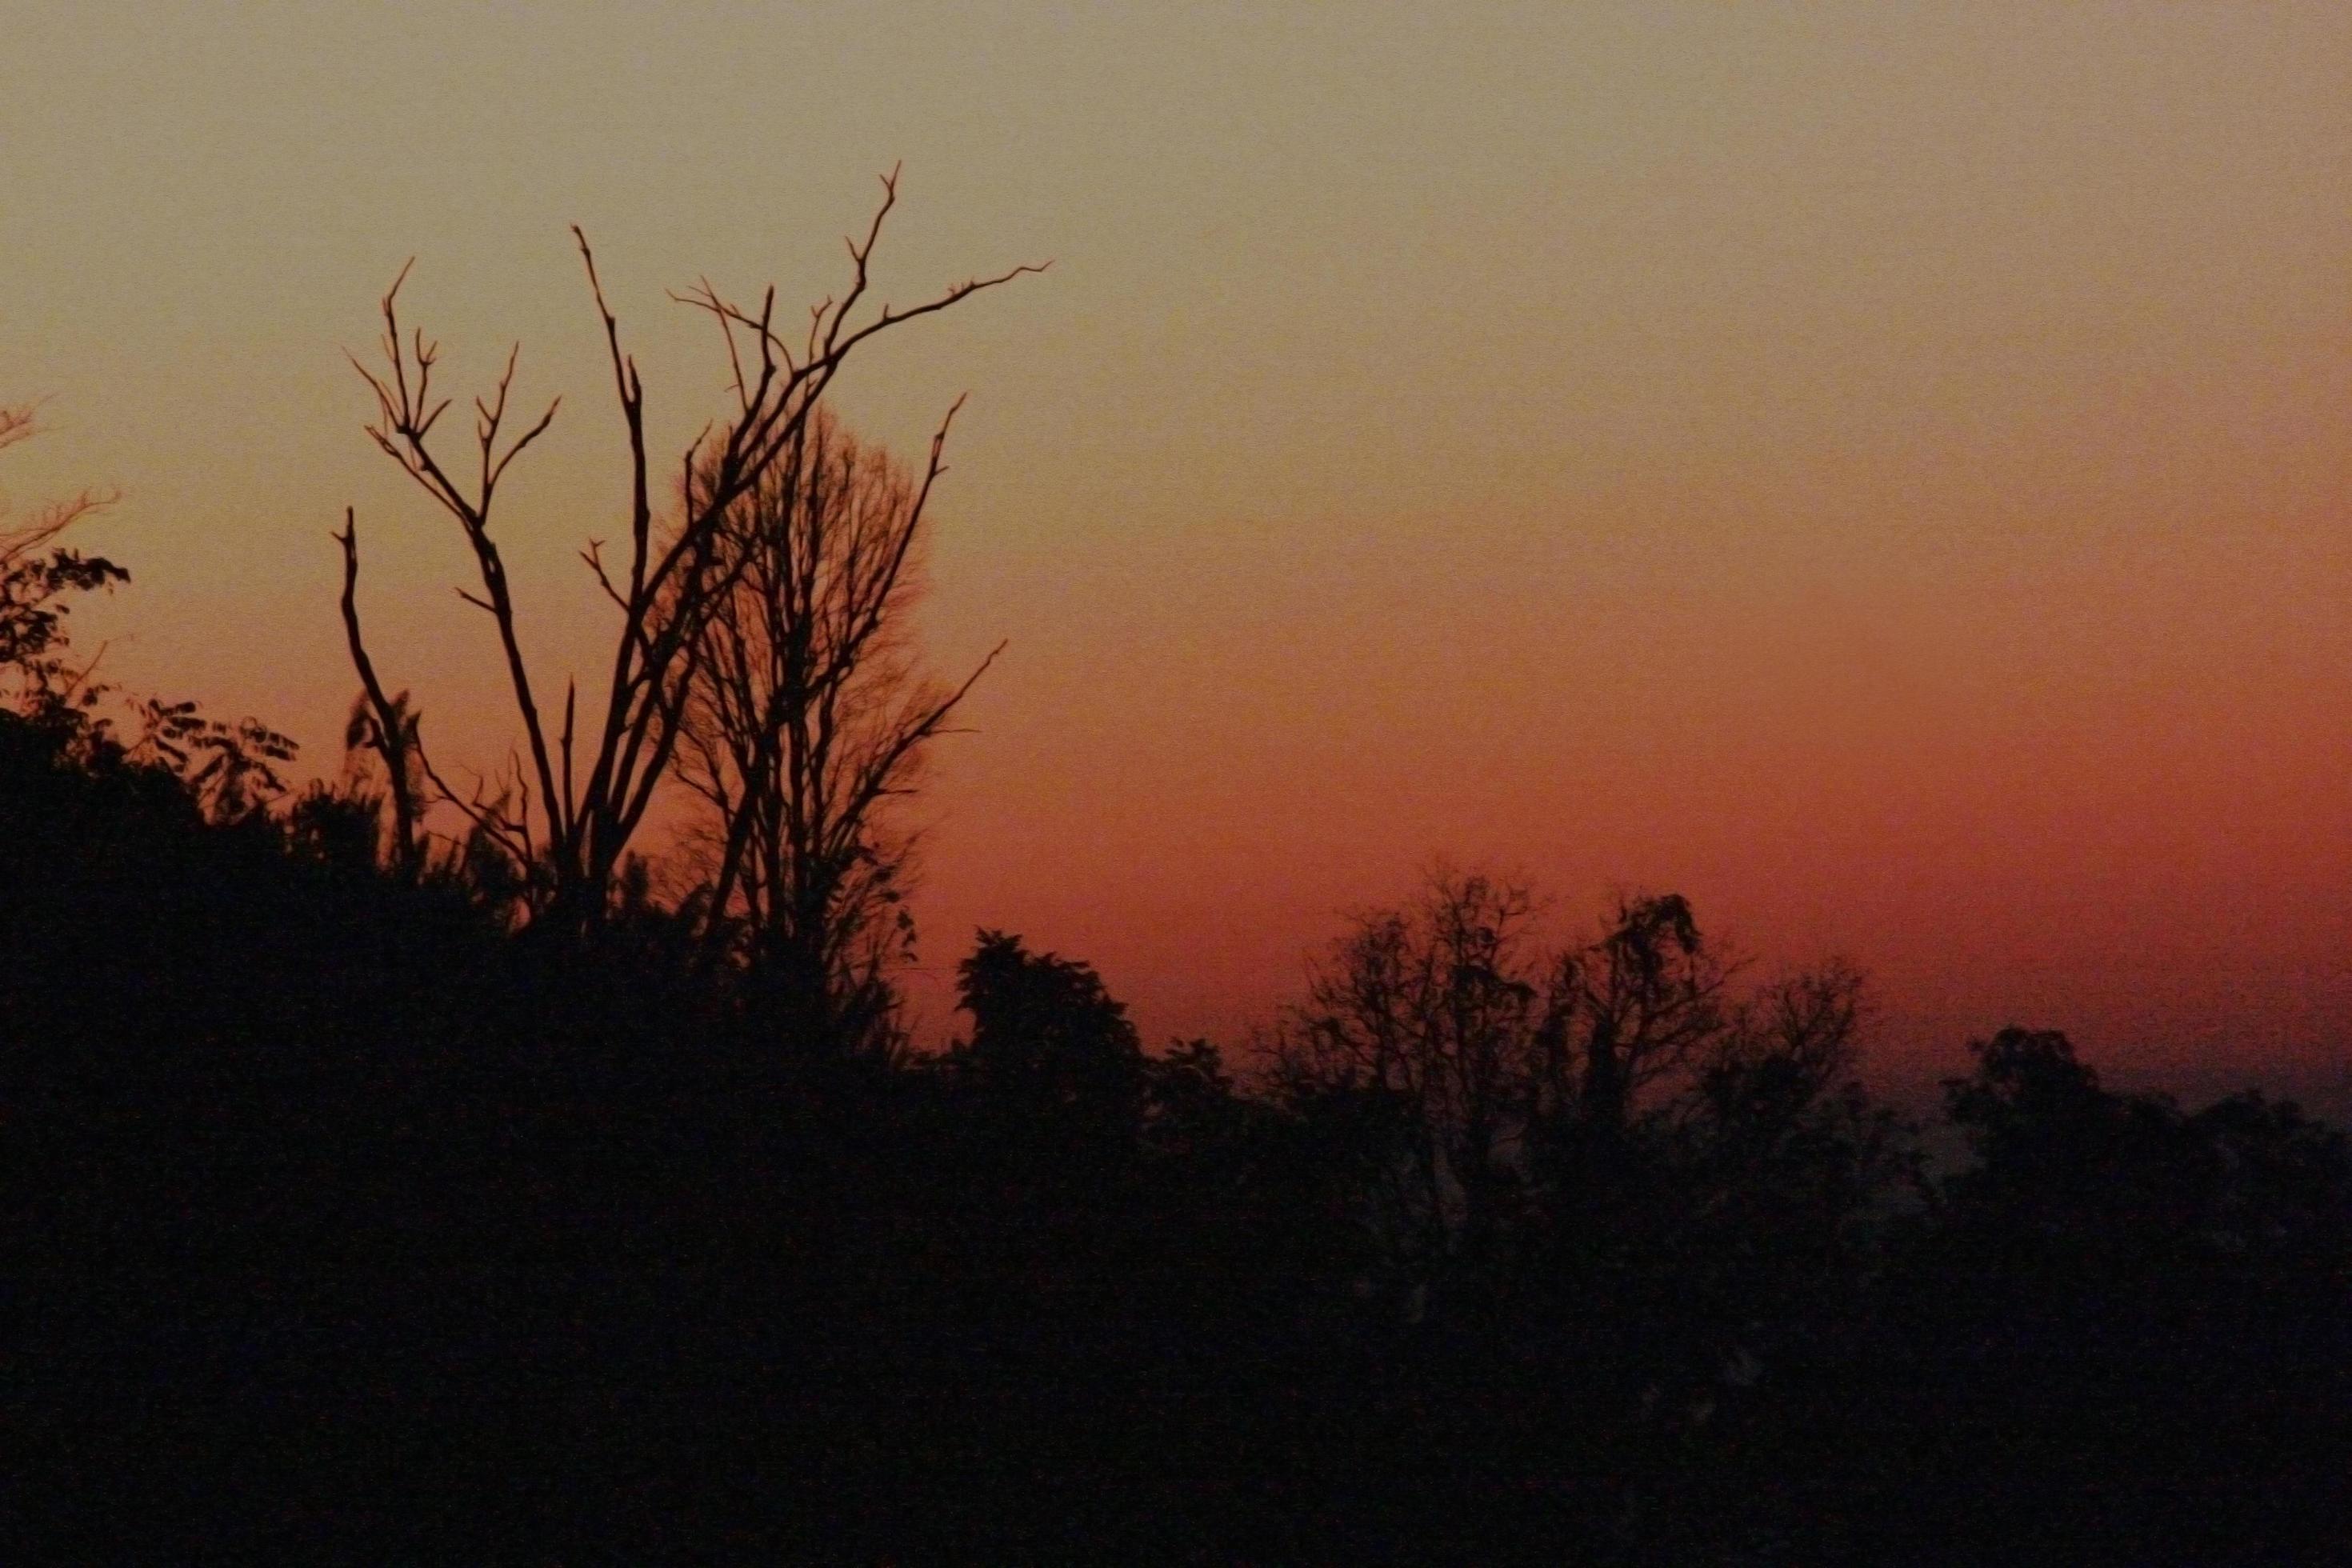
[{"left": 338, "top": 170, "right": 1042, "bottom": 929}]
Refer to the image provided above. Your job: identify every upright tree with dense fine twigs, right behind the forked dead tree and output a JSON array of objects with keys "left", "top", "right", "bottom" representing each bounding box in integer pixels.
[{"left": 678, "top": 409, "right": 995, "bottom": 1051}]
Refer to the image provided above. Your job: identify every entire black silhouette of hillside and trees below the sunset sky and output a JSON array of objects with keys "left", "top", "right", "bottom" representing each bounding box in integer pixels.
[{"left": 0, "top": 198, "right": 2352, "bottom": 1563}]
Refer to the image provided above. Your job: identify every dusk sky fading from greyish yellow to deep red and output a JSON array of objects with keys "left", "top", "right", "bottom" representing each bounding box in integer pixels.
[{"left": 0, "top": 0, "right": 2352, "bottom": 1102}]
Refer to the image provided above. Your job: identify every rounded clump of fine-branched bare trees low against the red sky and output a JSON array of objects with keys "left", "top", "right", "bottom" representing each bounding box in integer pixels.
[{"left": 1274, "top": 872, "right": 1740, "bottom": 1286}]
